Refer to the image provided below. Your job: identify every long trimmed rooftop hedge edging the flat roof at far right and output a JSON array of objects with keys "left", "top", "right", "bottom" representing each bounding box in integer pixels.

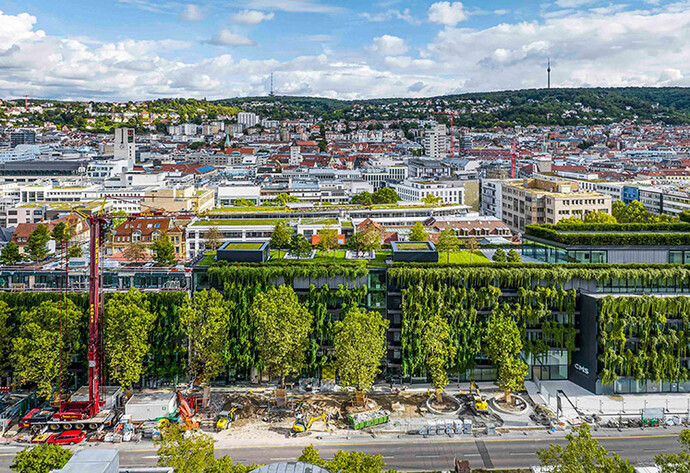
[{"left": 525, "top": 224, "right": 690, "bottom": 246}]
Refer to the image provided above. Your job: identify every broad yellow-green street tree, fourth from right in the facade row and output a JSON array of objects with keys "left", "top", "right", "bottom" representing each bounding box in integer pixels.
[{"left": 250, "top": 286, "right": 314, "bottom": 385}]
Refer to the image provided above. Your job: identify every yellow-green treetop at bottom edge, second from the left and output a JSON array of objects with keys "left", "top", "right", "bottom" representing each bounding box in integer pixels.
[{"left": 154, "top": 424, "right": 215, "bottom": 473}]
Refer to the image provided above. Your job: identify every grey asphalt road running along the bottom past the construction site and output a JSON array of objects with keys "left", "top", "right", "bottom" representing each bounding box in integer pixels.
[{"left": 0, "top": 430, "right": 680, "bottom": 472}]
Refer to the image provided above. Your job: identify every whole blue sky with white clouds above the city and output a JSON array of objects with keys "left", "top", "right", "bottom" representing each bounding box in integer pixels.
[{"left": 0, "top": 0, "right": 690, "bottom": 101}]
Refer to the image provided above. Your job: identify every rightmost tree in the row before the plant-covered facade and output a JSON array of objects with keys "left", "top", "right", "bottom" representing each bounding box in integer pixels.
[{"left": 483, "top": 304, "right": 528, "bottom": 403}]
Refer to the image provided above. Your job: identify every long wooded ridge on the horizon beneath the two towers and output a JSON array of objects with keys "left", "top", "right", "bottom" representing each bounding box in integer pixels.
[{"left": 218, "top": 87, "right": 690, "bottom": 127}]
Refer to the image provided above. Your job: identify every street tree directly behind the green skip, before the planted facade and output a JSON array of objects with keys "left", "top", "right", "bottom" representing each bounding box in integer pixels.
[{"left": 333, "top": 307, "right": 388, "bottom": 391}]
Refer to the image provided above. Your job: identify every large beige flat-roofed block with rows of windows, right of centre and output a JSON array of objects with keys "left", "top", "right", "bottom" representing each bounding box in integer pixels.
[{"left": 501, "top": 179, "right": 611, "bottom": 232}]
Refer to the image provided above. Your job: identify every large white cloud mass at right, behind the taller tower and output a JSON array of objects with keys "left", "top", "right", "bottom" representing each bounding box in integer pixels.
[{"left": 424, "top": 6, "right": 690, "bottom": 90}]
